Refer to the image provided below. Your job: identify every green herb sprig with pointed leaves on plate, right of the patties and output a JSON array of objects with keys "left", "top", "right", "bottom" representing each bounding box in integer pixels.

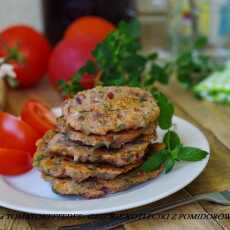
[{"left": 140, "top": 130, "right": 208, "bottom": 173}]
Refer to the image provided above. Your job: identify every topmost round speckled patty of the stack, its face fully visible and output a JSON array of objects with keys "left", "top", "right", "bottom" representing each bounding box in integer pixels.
[{"left": 63, "top": 86, "right": 160, "bottom": 135}]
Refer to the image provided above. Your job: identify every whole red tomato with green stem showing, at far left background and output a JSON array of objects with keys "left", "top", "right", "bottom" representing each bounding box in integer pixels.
[{"left": 0, "top": 25, "right": 51, "bottom": 87}]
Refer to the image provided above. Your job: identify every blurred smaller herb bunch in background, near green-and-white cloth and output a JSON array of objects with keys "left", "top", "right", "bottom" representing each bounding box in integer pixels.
[{"left": 170, "top": 36, "right": 221, "bottom": 89}]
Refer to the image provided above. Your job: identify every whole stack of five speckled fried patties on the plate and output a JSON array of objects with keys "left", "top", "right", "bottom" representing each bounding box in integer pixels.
[{"left": 34, "top": 87, "right": 164, "bottom": 198}]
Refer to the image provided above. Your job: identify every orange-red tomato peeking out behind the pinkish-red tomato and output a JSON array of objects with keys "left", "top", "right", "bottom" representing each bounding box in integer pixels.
[{"left": 65, "top": 16, "right": 115, "bottom": 42}]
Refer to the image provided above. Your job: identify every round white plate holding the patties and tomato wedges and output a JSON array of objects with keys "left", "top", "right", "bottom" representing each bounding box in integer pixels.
[{"left": 0, "top": 117, "right": 209, "bottom": 215}]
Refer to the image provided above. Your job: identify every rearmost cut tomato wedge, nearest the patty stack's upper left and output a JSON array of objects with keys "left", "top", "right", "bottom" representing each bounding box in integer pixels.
[{"left": 21, "top": 100, "right": 56, "bottom": 136}]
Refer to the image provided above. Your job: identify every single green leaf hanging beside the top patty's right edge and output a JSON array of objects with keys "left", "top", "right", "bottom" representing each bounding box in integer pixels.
[{"left": 152, "top": 91, "right": 174, "bottom": 129}]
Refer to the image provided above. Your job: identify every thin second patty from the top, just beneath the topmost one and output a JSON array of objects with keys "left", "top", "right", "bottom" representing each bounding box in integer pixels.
[{"left": 57, "top": 117, "right": 156, "bottom": 148}]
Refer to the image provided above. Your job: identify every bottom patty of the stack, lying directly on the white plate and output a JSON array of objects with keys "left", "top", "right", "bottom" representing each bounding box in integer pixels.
[{"left": 43, "top": 164, "right": 163, "bottom": 199}]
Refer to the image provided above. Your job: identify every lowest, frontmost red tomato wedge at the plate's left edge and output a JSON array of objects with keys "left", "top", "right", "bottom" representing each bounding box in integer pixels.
[{"left": 0, "top": 148, "right": 32, "bottom": 175}]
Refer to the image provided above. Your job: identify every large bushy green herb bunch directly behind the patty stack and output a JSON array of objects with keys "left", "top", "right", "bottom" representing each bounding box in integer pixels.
[{"left": 60, "top": 20, "right": 169, "bottom": 92}]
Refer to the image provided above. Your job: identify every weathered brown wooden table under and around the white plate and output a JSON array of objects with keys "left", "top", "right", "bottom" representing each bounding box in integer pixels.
[{"left": 0, "top": 77, "right": 230, "bottom": 230}]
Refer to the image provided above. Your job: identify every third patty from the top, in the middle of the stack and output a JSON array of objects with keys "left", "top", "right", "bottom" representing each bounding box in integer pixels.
[{"left": 34, "top": 131, "right": 153, "bottom": 167}]
